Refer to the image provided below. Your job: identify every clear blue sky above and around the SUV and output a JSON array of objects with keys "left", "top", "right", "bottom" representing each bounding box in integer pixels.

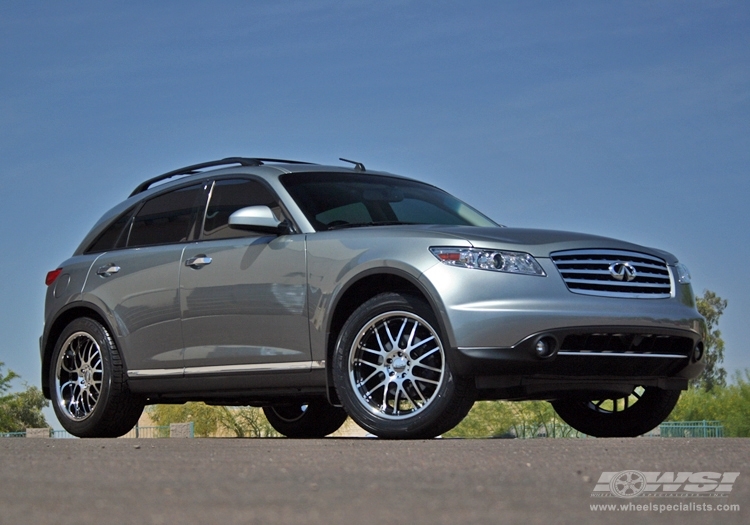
[{"left": 0, "top": 0, "right": 750, "bottom": 422}]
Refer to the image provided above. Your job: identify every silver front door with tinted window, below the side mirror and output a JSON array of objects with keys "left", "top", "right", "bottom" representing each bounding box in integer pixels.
[{"left": 180, "top": 178, "right": 310, "bottom": 376}]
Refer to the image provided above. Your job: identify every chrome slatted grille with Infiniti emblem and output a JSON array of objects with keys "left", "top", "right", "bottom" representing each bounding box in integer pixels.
[{"left": 550, "top": 250, "right": 672, "bottom": 299}]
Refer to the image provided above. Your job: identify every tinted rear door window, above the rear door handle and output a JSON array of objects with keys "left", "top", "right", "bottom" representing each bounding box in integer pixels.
[{"left": 128, "top": 184, "right": 205, "bottom": 246}]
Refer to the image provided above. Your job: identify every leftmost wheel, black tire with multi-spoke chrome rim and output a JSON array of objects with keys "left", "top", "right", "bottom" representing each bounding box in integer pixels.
[{"left": 49, "top": 317, "right": 144, "bottom": 438}]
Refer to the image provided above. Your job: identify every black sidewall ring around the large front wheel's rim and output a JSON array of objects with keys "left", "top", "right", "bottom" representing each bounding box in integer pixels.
[{"left": 333, "top": 293, "right": 455, "bottom": 439}]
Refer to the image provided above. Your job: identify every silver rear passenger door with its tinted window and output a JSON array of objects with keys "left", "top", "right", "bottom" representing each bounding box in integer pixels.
[{"left": 84, "top": 184, "right": 206, "bottom": 376}]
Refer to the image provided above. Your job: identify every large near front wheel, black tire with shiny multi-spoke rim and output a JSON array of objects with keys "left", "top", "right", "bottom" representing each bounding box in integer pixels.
[{"left": 333, "top": 293, "right": 474, "bottom": 439}]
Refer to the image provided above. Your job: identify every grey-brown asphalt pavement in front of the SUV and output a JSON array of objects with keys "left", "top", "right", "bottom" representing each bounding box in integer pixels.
[{"left": 0, "top": 438, "right": 750, "bottom": 525}]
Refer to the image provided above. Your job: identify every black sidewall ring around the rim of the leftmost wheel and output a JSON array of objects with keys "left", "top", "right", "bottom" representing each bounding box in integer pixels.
[{"left": 49, "top": 318, "right": 113, "bottom": 436}]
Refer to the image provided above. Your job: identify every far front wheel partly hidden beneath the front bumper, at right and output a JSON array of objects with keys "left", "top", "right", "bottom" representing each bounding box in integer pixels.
[{"left": 552, "top": 386, "right": 681, "bottom": 437}]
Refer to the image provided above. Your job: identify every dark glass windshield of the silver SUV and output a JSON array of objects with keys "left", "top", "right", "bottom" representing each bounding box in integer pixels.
[{"left": 281, "top": 173, "right": 498, "bottom": 231}]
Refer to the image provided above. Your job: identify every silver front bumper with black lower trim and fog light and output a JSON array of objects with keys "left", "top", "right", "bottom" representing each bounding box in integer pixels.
[{"left": 422, "top": 259, "right": 705, "bottom": 388}]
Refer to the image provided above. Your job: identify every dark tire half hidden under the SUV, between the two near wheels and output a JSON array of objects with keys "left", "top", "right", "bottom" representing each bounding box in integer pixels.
[{"left": 263, "top": 399, "right": 347, "bottom": 439}]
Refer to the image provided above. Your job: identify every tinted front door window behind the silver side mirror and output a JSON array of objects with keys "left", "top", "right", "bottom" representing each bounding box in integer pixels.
[{"left": 202, "top": 179, "right": 281, "bottom": 240}]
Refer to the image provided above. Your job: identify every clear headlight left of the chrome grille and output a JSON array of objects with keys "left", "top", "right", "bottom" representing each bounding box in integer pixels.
[{"left": 430, "top": 248, "right": 546, "bottom": 276}]
